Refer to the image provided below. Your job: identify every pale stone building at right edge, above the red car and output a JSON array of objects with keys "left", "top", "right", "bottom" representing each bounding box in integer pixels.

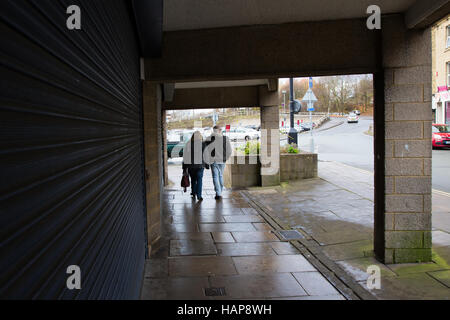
[{"left": 432, "top": 16, "right": 450, "bottom": 124}]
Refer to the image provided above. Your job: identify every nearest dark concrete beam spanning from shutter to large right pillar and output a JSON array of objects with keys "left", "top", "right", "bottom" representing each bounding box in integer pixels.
[{"left": 145, "top": 19, "right": 376, "bottom": 82}]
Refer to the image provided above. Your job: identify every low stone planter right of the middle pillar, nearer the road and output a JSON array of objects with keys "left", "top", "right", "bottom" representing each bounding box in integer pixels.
[{"left": 280, "top": 151, "right": 317, "bottom": 181}]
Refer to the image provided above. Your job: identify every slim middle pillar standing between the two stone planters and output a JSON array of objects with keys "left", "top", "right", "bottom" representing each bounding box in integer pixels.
[{"left": 259, "top": 86, "right": 280, "bottom": 187}]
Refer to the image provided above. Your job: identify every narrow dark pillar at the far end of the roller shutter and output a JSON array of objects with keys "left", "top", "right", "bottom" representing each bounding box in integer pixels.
[{"left": 143, "top": 81, "right": 163, "bottom": 255}]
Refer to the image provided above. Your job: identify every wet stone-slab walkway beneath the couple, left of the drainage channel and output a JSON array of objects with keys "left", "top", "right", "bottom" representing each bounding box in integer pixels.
[{"left": 141, "top": 166, "right": 344, "bottom": 300}]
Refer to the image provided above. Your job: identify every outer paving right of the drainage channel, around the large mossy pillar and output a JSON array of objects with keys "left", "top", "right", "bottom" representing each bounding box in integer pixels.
[{"left": 249, "top": 162, "right": 450, "bottom": 299}]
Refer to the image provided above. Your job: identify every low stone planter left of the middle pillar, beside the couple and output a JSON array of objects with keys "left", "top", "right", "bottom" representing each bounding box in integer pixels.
[{"left": 223, "top": 156, "right": 261, "bottom": 188}]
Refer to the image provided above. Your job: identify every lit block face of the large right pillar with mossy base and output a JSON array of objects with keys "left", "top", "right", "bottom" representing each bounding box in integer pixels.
[{"left": 382, "top": 15, "right": 432, "bottom": 263}]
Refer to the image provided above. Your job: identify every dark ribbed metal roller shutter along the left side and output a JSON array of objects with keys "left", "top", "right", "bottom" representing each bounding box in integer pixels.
[{"left": 0, "top": 0, "right": 146, "bottom": 299}]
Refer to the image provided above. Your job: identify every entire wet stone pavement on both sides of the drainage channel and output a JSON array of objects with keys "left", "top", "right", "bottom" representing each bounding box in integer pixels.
[{"left": 142, "top": 162, "right": 450, "bottom": 300}]
